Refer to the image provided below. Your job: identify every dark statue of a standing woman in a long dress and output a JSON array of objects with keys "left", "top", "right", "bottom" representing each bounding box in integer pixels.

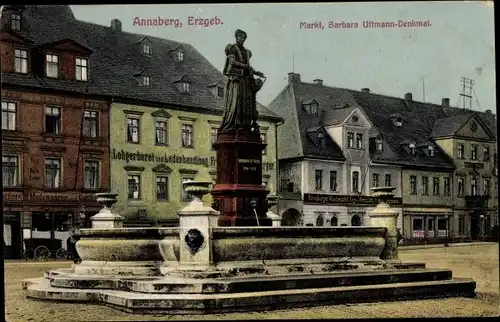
[{"left": 219, "top": 29, "right": 264, "bottom": 131}]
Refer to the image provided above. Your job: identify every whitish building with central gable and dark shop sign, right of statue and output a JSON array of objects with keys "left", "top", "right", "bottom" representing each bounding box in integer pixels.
[{"left": 269, "top": 73, "right": 402, "bottom": 227}]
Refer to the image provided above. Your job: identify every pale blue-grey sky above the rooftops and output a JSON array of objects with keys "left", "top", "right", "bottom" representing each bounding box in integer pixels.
[{"left": 71, "top": 1, "right": 496, "bottom": 114}]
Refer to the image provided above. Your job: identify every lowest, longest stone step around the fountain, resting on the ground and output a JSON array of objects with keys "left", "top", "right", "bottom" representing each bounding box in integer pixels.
[{"left": 27, "top": 278, "right": 476, "bottom": 314}]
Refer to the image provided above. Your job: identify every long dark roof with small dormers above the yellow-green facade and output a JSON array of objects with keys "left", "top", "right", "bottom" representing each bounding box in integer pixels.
[{"left": 2, "top": 5, "right": 279, "bottom": 120}]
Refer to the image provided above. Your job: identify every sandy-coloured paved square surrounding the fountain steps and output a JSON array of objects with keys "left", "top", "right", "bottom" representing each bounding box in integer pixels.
[{"left": 5, "top": 243, "right": 500, "bottom": 322}]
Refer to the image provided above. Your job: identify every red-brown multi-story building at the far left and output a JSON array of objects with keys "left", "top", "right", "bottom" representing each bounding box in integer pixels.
[{"left": 0, "top": 6, "right": 109, "bottom": 258}]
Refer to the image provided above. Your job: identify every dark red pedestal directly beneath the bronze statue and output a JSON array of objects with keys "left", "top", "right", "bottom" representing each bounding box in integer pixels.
[{"left": 212, "top": 128, "right": 271, "bottom": 226}]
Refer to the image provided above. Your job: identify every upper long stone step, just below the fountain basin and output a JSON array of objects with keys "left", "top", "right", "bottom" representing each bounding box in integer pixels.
[{"left": 50, "top": 269, "right": 452, "bottom": 294}]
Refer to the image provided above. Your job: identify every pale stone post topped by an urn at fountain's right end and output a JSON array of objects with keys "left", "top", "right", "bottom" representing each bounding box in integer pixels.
[{"left": 369, "top": 187, "right": 399, "bottom": 262}]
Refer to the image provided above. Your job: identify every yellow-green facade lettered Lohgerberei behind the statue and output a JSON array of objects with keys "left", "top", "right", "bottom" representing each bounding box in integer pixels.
[{"left": 110, "top": 103, "right": 276, "bottom": 224}]
